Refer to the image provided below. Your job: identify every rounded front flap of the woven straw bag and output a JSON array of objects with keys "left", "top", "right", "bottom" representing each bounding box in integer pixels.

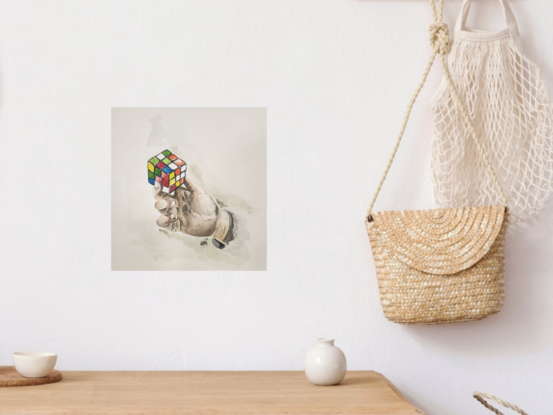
[{"left": 366, "top": 205, "right": 505, "bottom": 275}]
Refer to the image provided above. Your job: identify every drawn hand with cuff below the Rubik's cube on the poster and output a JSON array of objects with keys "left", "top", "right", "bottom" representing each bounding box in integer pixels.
[{"left": 153, "top": 176, "right": 232, "bottom": 248}]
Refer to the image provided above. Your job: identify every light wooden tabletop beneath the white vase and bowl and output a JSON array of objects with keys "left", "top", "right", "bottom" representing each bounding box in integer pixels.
[{"left": 0, "top": 371, "right": 423, "bottom": 415}]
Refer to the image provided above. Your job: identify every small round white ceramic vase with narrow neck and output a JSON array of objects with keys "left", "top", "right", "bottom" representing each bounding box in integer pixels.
[{"left": 305, "top": 339, "right": 347, "bottom": 386}]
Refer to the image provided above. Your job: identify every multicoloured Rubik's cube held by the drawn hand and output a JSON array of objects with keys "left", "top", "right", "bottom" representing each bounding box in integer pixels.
[{"left": 148, "top": 150, "right": 186, "bottom": 194}]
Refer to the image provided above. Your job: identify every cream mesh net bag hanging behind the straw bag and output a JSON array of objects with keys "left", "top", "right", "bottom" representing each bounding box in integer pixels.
[{"left": 429, "top": 0, "right": 553, "bottom": 222}]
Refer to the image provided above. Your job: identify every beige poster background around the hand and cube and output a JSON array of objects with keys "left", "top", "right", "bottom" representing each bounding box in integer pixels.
[{"left": 111, "top": 108, "right": 267, "bottom": 271}]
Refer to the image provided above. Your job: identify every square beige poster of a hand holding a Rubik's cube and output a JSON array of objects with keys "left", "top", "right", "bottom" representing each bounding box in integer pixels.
[{"left": 111, "top": 108, "right": 267, "bottom": 271}]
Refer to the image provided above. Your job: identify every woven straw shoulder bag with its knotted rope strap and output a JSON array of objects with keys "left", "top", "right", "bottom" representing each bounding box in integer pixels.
[{"left": 365, "top": 0, "right": 509, "bottom": 324}]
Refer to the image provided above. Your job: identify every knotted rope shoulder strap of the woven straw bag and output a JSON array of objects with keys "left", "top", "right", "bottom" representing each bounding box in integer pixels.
[{"left": 366, "top": 0, "right": 507, "bottom": 222}]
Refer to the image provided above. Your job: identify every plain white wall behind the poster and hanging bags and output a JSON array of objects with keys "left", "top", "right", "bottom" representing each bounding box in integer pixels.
[{"left": 0, "top": 0, "right": 553, "bottom": 415}]
